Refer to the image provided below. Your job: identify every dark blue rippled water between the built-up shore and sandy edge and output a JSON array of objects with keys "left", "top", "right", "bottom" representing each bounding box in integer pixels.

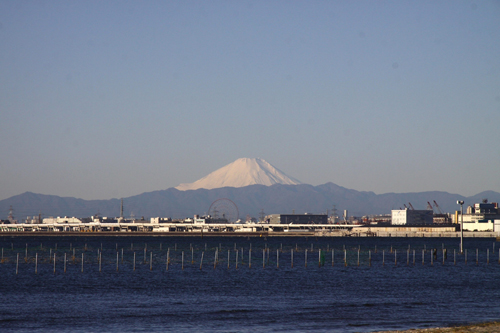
[{"left": 0, "top": 236, "right": 500, "bottom": 332}]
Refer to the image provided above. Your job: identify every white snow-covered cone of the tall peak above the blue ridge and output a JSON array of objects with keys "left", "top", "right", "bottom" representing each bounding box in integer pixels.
[{"left": 176, "top": 158, "right": 301, "bottom": 191}]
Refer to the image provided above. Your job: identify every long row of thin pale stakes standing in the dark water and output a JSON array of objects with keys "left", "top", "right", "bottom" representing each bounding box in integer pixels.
[{"left": 1, "top": 243, "right": 500, "bottom": 274}]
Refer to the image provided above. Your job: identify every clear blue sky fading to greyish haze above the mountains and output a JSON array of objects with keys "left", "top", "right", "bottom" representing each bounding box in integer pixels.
[{"left": 0, "top": 0, "right": 500, "bottom": 199}]
